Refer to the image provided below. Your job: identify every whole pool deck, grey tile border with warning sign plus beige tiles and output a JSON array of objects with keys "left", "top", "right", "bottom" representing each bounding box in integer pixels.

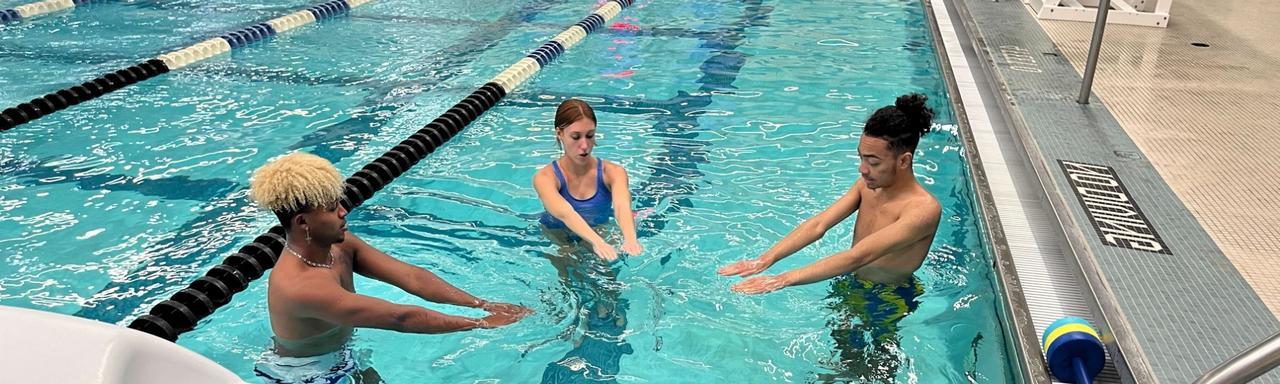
[{"left": 946, "top": 0, "right": 1280, "bottom": 383}]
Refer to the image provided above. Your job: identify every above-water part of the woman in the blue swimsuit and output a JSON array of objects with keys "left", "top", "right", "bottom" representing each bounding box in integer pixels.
[{"left": 534, "top": 99, "right": 643, "bottom": 262}]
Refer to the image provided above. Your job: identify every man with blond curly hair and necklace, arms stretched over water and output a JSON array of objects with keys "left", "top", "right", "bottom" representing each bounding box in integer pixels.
[{"left": 250, "top": 152, "right": 530, "bottom": 383}]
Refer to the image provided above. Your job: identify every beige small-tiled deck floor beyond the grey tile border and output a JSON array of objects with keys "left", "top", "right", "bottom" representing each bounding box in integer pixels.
[{"left": 1039, "top": 0, "right": 1280, "bottom": 316}]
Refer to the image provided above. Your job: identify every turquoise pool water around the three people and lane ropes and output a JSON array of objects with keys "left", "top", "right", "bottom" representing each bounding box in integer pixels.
[{"left": 0, "top": 0, "right": 1012, "bottom": 383}]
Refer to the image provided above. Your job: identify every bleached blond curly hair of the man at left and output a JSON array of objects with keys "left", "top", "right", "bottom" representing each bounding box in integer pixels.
[{"left": 248, "top": 152, "right": 343, "bottom": 228}]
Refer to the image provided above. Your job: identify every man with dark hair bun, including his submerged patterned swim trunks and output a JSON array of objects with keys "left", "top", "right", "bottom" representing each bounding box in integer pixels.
[{"left": 719, "top": 93, "right": 942, "bottom": 383}]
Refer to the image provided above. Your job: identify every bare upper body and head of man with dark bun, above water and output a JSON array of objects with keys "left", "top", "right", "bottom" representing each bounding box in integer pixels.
[{"left": 719, "top": 93, "right": 942, "bottom": 294}]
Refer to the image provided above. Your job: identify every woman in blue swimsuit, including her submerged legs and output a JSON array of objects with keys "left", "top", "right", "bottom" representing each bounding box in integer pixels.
[{"left": 534, "top": 99, "right": 643, "bottom": 383}]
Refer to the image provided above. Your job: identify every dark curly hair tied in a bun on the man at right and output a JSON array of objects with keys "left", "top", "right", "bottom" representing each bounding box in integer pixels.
[{"left": 863, "top": 93, "right": 933, "bottom": 154}]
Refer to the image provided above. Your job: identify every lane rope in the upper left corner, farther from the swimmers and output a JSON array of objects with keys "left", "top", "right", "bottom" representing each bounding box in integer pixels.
[{"left": 0, "top": 0, "right": 371, "bottom": 131}]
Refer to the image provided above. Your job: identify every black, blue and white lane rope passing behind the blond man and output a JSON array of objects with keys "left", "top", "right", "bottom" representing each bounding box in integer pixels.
[{"left": 129, "top": 0, "right": 632, "bottom": 340}]
